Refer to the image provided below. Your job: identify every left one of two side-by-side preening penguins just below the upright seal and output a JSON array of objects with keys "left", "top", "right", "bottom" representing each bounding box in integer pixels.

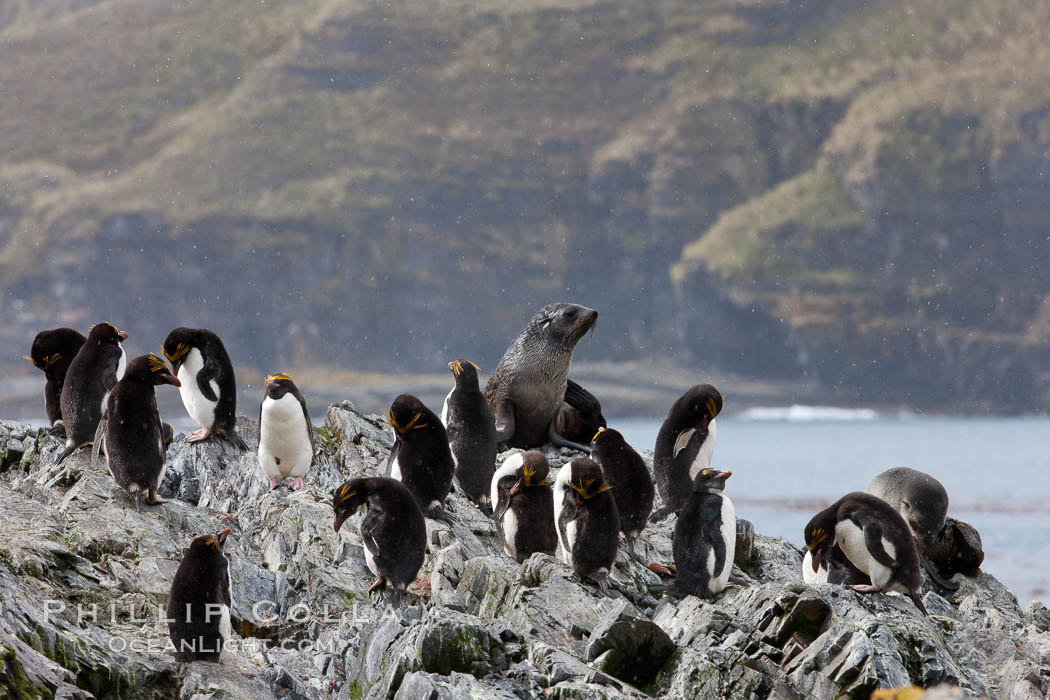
[{"left": 491, "top": 450, "right": 558, "bottom": 564}]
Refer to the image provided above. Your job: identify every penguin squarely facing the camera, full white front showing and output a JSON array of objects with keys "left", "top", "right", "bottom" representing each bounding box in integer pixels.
[{"left": 258, "top": 374, "right": 314, "bottom": 491}]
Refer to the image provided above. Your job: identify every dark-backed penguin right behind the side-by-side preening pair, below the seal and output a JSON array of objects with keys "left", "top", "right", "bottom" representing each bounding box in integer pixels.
[{"left": 591, "top": 428, "right": 655, "bottom": 558}]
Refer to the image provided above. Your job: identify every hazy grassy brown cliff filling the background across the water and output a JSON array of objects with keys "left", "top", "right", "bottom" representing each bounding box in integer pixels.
[{"left": 0, "top": 0, "right": 1050, "bottom": 411}]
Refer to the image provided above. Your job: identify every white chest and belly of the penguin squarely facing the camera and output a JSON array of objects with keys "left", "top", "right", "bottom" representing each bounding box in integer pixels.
[{"left": 258, "top": 394, "right": 314, "bottom": 479}]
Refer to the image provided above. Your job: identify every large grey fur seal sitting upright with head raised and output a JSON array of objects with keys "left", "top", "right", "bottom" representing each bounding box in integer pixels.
[{"left": 485, "top": 303, "right": 605, "bottom": 453}]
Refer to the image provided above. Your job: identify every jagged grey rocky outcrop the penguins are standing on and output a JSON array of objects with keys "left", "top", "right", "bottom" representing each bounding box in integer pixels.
[{"left": 0, "top": 403, "right": 1050, "bottom": 700}]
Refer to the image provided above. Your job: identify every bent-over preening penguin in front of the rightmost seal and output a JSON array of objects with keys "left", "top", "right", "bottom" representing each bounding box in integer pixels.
[{"left": 804, "top": 491, "right": 926, "bottom": 615}]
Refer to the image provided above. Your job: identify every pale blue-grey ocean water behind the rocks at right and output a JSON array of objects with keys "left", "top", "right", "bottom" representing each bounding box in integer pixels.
[{"left": 609, "top": 415, "right": 1050, "bottom": 607}]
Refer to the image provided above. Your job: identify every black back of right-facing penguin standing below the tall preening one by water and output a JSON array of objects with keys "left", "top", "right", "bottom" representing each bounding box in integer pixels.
[{"left": 673, "top": 491, "right": 732, "bottom": 598}]
